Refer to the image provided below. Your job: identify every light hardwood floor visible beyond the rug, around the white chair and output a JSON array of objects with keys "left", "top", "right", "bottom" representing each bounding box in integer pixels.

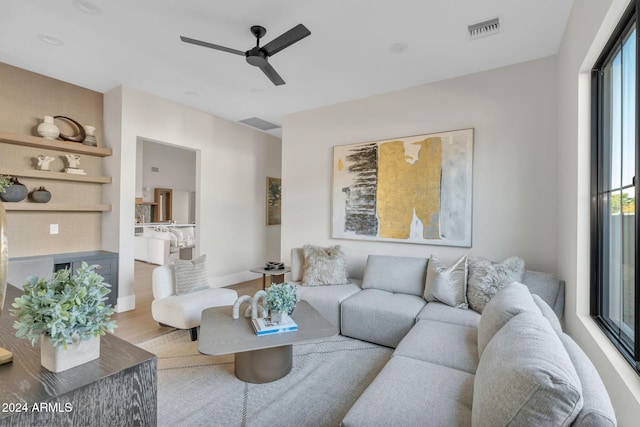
[{"left": 113, "top": 261, "right": 262, "bottom": 344}]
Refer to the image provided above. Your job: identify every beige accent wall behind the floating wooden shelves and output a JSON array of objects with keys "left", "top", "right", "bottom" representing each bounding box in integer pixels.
[{"left": 0, "top": 63, "right": 105, "bottom": 258}]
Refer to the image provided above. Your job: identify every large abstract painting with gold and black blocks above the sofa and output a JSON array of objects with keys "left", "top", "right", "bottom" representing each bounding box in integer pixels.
[{"left": 332, "top": 129, "right": 473, "bottom": 247}]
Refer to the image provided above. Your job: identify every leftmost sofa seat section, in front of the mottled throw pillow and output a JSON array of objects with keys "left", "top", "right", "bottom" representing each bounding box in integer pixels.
[{"left": 290, "top": 279, "right": 361, "bottom": 328}]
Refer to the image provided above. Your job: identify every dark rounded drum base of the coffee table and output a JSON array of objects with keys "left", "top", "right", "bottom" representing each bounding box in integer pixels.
[{"left": 235, "top": 345, "right": 293, "bottom": 384}]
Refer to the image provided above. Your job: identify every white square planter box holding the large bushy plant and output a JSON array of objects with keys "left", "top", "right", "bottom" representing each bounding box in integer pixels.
[{"left": 40, "top": 335, "right": 100, "bottom": 373}]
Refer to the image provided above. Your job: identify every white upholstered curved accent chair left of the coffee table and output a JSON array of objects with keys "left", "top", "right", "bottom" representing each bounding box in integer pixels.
[{"left": 151, "top": 264, "right": 238, "bottom": 341}]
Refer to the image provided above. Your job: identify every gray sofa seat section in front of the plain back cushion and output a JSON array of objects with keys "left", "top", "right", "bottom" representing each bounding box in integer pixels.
[{"left": 340, "top": 289, "right": 425, "bottom": 347}]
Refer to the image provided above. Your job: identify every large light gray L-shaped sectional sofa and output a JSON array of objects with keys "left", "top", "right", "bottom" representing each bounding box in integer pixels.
[{"left": 291, "top": 248, "right": 616, "bottom": 427}]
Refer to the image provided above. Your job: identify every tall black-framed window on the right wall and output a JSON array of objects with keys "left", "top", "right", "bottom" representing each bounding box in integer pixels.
[{"left": 591, "top": 0, "right": 640, "bottom": 371}]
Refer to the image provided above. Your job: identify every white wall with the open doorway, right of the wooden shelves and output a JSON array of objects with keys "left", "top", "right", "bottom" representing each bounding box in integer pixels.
[{"left": 103, "top": 87, "right": 281, "bottom": 311}]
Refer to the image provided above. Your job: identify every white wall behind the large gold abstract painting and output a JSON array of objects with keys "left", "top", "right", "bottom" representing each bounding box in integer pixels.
[{"left": 282, "top": 58, "right": 558, "bottom": 276}]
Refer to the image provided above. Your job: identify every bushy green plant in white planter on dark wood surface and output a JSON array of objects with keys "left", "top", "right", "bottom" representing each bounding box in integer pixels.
[{"left": 10, "top": 262, "right": 116, "bottom": 372}]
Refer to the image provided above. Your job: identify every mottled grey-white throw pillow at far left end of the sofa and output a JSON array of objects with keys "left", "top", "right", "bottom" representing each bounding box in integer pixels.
[{"left": 302, "top": 245, "right": 351, "bottom": 286}]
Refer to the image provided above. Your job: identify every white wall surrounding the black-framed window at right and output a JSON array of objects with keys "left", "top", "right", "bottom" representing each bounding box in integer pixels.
[{"left": 558, "top": 0, "right": 640, "bottom": 426}]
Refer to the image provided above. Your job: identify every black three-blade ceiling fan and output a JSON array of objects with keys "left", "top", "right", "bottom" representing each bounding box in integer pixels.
[{"left": 180, "top": 24, "right": 311, "bottom": 86}]
